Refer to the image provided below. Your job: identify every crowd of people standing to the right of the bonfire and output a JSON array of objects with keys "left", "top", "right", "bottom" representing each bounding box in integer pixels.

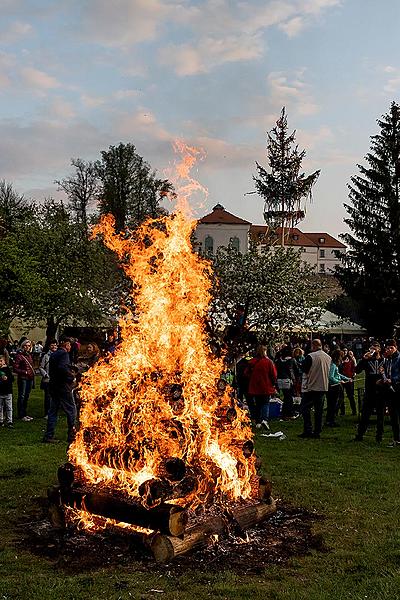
[{"left": 235, "top": 338, "right": 400, "bottom": 447}]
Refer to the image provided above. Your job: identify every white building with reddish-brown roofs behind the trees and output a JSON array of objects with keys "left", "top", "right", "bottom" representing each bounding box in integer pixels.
[{"left": 195, "top": 204, "right": 346, "bottom": 275}]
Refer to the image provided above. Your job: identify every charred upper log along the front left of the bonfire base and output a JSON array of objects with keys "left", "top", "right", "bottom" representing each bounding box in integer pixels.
[{"left": 60, "top": 488, "right": 188, "bottom": 536}]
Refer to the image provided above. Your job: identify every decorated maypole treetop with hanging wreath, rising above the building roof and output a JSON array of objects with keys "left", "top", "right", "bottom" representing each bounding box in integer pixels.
[{"left": 253, "top": 108, "right": 320, "bottom": 245}]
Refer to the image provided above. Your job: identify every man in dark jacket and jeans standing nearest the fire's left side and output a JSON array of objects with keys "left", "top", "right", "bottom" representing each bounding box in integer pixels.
[{"left": 43, "top": 337, "right": 76, "bottom": 444}]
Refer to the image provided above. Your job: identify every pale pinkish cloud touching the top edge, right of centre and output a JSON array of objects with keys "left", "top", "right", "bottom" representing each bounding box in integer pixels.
[{"left": 159, "top": 0, "right": 340, "bottom": 76}]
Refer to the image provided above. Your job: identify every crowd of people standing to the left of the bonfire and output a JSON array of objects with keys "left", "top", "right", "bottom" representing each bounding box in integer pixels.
[{"left": 0, "top": 334, "right": 116, "bottom": 443}]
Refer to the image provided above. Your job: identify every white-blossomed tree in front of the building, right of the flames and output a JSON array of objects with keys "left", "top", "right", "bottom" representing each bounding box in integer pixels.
[{"left": 210, "top": 247, "right": 321, "bottom": 352}]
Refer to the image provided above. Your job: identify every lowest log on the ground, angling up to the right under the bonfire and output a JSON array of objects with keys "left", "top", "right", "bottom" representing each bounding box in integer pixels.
[{"left": 150, "top": 500, "right": 276, "bottom": 562}]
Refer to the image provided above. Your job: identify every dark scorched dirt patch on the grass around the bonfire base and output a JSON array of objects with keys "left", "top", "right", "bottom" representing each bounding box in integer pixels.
[{"left": 15, "top": 499, "right": 326, "bottom": 575}]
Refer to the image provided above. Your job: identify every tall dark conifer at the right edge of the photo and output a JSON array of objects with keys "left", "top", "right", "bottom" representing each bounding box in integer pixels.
[{"left": 337, "top": 102, "right": 400, "bottom": 336}]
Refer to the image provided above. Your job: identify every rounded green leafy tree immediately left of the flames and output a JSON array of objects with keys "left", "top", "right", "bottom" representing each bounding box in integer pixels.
[{"left": 22, "top": 200, "right": 121, "bottom": 339}]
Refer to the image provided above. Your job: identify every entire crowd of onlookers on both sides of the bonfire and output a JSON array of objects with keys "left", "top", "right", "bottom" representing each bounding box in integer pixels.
[{"left": 0, "top": 334, "right": 400, "bottom": 446}]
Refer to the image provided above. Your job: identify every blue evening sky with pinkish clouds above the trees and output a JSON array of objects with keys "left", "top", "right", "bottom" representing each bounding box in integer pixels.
[{"left": 0, "top": 0, "right": 400, "bottom": 236}]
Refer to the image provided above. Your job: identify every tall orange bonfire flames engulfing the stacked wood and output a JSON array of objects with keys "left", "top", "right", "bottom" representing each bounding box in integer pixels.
[{"left": 69, "top": 146, "right": 257, "bottom": 508}]
